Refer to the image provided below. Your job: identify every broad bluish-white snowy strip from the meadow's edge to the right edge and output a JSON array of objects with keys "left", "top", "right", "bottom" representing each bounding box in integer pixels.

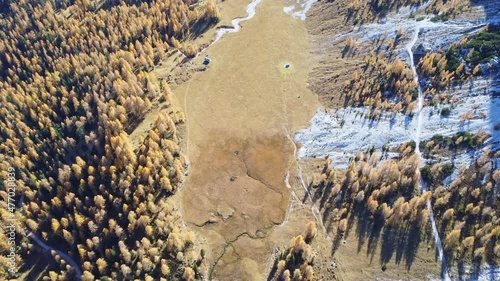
[{"left": 295, "top": 79, "right": 500, "bottom": 168}]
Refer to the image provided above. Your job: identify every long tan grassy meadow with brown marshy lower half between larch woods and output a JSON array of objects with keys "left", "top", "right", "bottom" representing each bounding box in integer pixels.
[{"left": 175, "top": 1, "right": 317, "bottom": 280}]
